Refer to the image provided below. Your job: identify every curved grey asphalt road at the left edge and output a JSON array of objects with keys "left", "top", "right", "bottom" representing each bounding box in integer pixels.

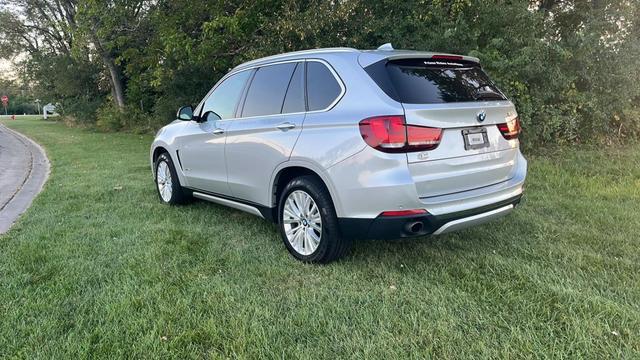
[{"left": 0, "top": 124, "right": 50, "bottom": 234}]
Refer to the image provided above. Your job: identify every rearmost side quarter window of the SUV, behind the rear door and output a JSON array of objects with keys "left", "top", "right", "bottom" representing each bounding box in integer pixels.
[{"left": 307, "top": 61, "right": 342, "bottom": 111}]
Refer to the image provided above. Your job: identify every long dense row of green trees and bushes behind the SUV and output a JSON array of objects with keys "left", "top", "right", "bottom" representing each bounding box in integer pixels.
[{"left": 0, "top": 0, "right": 640, "bottom": 144}]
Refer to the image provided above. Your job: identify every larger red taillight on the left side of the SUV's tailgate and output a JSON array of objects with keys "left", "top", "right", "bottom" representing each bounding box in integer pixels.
[{"left": 360, "top": 115, "right": 442, "bottom": 153}]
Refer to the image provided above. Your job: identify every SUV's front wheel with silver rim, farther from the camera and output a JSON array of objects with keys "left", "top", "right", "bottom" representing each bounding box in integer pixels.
[{"left": 154, "top": 152, "right": 191, "bottom": 205}]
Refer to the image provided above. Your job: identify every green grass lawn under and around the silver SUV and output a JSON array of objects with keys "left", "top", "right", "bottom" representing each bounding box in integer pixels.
[{"left": 0, "top": 119, "right": 640, "bottom": 359}]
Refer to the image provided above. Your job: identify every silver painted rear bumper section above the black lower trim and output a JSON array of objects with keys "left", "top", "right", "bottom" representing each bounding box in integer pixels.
[{"left": 327, "top": 147, "right": 527, "bottom": 219}]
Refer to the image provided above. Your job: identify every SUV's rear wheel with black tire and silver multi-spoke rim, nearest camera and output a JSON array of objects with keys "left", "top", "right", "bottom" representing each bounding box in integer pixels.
[{"left": 278, "top": 176, "right": 351, "bottom": 264}]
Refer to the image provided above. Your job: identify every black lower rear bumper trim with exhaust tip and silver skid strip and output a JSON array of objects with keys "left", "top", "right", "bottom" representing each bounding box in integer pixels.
[{"left": 338, "top": 194, "right": 522, "bottom": 240}]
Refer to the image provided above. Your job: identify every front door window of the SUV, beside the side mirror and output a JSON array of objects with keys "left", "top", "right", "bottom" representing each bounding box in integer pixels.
[{"left": 202, "top": 71, "right": 251, "bottom": 119}]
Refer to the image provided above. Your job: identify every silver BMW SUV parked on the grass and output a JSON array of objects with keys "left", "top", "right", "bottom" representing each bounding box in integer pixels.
[{"left": 150, "top": 44, "right": 527, "bottom": 263}]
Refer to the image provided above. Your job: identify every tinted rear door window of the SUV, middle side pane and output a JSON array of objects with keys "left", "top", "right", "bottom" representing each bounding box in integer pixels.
[{"left": 242, "top": 63, "right": 296, "bottom": 117}]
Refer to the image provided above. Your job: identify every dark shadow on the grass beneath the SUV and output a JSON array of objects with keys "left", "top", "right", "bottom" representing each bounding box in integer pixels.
[{"left": 162, "top": 194, "right": 536, "bottom": 267}]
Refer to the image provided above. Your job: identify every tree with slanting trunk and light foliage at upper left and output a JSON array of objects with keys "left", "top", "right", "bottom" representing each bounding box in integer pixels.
[{"left": 0, "top": 0, "right": 151, "bottom": 109}]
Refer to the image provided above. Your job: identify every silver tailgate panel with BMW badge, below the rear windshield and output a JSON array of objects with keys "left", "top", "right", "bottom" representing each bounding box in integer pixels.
[{"left": 404, "top": 102, "right": 518, "bottom": 197}]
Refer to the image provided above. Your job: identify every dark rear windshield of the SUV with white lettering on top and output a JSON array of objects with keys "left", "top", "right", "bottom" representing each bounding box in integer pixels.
[{"left": 365, "top": 59, "right": 506, "bottom": 104}]
